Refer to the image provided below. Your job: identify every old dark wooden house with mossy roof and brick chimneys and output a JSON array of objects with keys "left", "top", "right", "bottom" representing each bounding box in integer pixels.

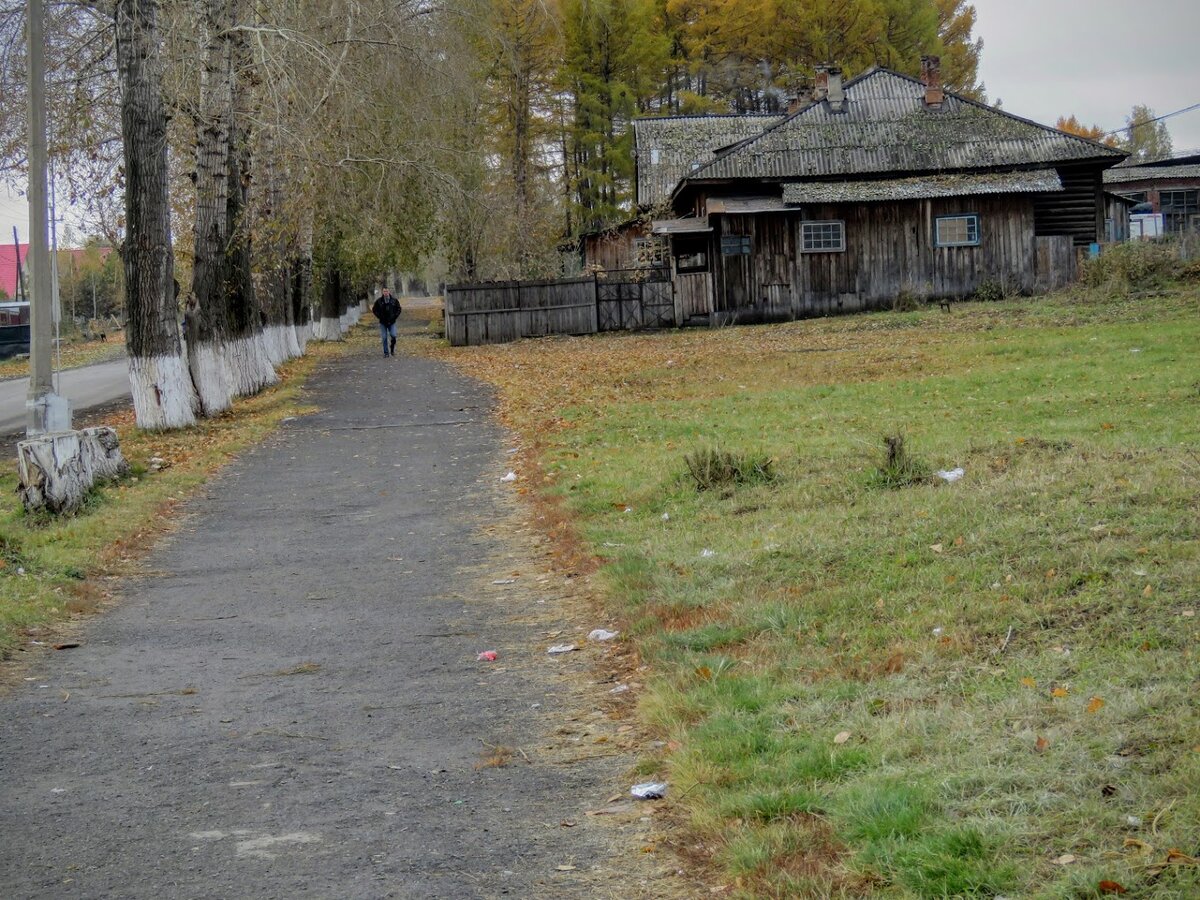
[{"left": 635, "top": 58, "right": 1123, "bottom": 323}]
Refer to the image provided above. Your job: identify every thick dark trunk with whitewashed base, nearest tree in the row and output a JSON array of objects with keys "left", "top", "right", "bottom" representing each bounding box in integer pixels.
[{"left": 115, "top": 0, "right": 197, "bottom": 428}]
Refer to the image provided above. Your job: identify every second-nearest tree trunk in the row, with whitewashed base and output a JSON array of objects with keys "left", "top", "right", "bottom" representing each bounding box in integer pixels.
[{"left": 187, "top": 0, "right": 234, "bottom": 416}]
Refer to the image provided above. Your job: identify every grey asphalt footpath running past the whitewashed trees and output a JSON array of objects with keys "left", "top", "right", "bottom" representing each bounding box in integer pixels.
[{"left": 0, "top": 328, "right": 673, "bottom": 900}]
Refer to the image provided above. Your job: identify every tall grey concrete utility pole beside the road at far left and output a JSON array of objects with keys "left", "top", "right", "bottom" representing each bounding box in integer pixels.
[{"left": 25, "top": 0, "right": 71, "bottom": 437}]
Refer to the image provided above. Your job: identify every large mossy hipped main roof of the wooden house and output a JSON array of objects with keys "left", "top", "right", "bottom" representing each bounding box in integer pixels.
[{"left": 688, "top": 68, "right": 1123, "bottom": 187}]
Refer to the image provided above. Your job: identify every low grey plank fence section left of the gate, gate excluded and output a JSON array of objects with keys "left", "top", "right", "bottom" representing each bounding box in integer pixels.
[{"left": 445, "top": 278, "right": 596, "bottom": 347}]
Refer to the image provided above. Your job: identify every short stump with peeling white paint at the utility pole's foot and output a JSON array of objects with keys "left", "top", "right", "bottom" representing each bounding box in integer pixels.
[{"left": 17, "top": 428, "right": 130, "bottom": 512}]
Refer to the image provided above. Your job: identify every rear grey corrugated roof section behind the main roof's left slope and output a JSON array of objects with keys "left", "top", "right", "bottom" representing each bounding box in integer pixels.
[{"left": 634, "top": 115, "right": 782, "bottom": 206}]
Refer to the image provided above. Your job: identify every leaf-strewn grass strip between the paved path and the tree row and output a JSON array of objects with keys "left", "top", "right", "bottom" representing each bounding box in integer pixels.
[{"left": 0, "top": 329, "right": 352, "bottom": 660}]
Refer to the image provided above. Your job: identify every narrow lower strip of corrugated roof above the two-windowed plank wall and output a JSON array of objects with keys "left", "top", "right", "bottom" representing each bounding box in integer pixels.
[{"left": 784, "top": 169, "right": 1062, "bottom": 204}]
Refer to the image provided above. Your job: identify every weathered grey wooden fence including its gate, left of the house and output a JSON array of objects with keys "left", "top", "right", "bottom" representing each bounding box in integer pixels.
[{"left": 445, "top": 269, "right": 676, "bottom": 347}]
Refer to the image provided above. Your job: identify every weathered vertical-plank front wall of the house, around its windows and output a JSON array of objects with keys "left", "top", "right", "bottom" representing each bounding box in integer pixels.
[{"left": 705, "top": 196, "right": 1046, "bottom": 320}]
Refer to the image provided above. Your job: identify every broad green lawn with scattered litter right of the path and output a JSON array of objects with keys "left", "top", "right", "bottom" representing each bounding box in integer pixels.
[{"left": 426, "top": 284, "right": 1200, "bottom": 899}]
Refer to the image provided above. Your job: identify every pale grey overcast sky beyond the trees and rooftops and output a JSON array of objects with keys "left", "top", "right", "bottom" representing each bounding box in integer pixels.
[{"left": 0, "top": 0, "right": 1200, "bottom": 242}]
